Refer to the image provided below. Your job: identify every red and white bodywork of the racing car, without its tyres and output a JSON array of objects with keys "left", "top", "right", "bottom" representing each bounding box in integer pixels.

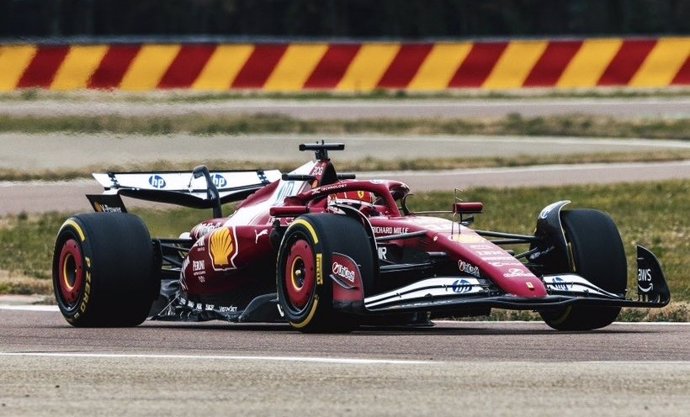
[{"left": 79, "top": 143, "right": 670, "bottom": 324}]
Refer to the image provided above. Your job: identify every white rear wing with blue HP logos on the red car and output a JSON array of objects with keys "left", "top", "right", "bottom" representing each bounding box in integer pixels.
[{"left": 87, "top": 166, "right": 281, "bottom": 213}]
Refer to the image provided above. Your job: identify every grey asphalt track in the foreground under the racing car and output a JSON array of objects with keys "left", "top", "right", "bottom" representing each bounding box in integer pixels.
[{"left": 0, "top": 307, "right": 690, "bottom": 416}]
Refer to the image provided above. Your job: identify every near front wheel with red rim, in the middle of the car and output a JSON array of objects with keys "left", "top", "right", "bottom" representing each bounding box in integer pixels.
[{"left": 276, "top": 214, "right": 374, "bottom": 333}]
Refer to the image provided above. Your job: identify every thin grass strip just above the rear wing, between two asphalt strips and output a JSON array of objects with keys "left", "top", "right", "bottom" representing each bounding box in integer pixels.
[{"left": 0, "top": 149, "right": 690, "bottom": 181}]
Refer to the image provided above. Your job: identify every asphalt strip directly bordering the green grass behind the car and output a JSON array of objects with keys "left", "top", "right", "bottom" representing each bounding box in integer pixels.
[{"left": 5, "top": 161, "right": 690, "bottom": 216}]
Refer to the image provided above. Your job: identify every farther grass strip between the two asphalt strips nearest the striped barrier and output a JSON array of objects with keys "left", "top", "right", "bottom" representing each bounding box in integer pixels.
[{"left": 0, "top": 114, "right": 690, "bottom": 140}]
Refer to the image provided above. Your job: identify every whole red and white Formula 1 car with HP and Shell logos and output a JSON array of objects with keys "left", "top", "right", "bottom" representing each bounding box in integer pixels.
[{"left": 53, "top": 142, "right": 670, "bottom": 332}]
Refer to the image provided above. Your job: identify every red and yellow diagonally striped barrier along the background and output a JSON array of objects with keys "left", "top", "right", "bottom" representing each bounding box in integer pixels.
[{"left": 0, "top": 37, "right": 690, "bottom": 92}]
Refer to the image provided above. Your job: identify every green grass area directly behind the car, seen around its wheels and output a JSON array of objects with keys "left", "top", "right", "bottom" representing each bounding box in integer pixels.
[{"left": 0, "top": 181, "right": 690, "bottom": 308}]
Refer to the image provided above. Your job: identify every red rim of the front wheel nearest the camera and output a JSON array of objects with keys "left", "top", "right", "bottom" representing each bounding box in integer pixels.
[{"left": 284, "top": 239, "right": 316, "bottom": 310}]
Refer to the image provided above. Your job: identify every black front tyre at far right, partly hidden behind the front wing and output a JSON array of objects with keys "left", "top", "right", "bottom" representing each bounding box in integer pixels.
[{"left": 541, "top": 209, "right": 627, "bottom": 330}]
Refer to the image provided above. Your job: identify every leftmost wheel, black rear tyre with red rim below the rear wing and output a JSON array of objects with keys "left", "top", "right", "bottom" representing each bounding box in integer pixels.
[{"left": 53, "top": 213, "right": 158, "bottom": 327}]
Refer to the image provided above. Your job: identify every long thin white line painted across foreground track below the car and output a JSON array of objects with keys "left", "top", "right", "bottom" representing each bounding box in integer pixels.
[{"left": 0, "top": 352, "right": 430, "bottom": 365}]
